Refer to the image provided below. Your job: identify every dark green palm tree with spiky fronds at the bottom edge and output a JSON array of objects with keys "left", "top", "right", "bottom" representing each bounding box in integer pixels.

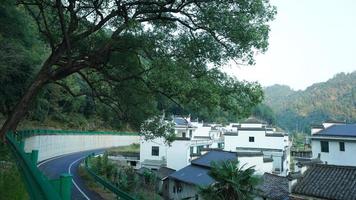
[{"left": 200, "top": 160, "right": 259, "bottom": 200}]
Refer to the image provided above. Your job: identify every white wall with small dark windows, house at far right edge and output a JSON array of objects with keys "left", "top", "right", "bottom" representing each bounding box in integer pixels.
[{"left": 311, "top": 139, "right": 356, "bottom": 166}]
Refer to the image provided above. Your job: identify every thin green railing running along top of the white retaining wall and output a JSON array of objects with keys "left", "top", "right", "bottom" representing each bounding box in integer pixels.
[{"left": 18, "top": 129, "right": 139, "bottom": 138}]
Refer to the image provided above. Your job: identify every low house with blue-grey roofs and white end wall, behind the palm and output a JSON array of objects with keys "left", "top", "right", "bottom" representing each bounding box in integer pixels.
[{"left": 164, "top": 150, "right": 272, "bottom": 200}]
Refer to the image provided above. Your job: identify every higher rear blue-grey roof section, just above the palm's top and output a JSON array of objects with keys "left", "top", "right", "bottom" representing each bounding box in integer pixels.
[{"left": 192, "top": 150, "right": 237, "bottom": 167}]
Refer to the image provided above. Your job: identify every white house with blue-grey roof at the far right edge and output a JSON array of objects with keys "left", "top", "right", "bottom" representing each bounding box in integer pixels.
[{"left": 310, "top": 121, "right": 356, "bottom": 166}]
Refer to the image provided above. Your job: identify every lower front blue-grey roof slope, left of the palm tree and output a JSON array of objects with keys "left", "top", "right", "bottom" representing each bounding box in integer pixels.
[{"left": 169, "top": 165, "right": 215, "bottom": 186}]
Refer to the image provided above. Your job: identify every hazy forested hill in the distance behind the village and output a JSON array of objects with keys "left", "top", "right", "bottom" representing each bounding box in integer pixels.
[{"left": 264, "top": 71, "right": 356, "bottom": 132}]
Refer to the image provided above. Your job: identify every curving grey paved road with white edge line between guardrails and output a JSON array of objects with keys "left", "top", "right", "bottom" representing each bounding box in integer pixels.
[{"left": 38, "top": 149, "right": 103, "bottom": 200}]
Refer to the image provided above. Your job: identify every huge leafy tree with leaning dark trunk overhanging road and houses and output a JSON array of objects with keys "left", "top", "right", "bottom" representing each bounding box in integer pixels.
[{"left": 0, "top": 0, "right": 275, "bottom": 140}]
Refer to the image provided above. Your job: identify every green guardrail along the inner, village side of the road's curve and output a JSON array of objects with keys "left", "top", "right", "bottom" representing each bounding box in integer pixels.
[{"left": 84, "top": 154, "right": 136, "bottom": 200}]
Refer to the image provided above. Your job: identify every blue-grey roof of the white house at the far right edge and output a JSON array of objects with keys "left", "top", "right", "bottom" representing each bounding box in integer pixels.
[{"left": 313, "top": 124, "right": 356, "bottom": 137}]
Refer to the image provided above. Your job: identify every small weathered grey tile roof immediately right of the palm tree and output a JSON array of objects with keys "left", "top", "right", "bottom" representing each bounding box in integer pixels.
[{"left": 257, "top": 173, "right": 289, "bottom": 200}]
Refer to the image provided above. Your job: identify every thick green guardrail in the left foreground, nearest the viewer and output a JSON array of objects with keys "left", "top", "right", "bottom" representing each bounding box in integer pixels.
[{"left": 6, "top": 132, "right": 72, "bottom": 200}]
